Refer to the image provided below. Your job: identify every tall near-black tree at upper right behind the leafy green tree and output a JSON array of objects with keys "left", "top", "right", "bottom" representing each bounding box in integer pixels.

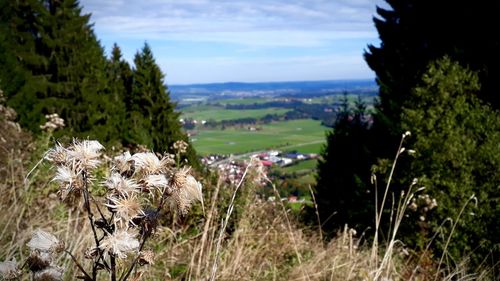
[{"left": 365, "top": 0, "right": 500, "bottom": 129}]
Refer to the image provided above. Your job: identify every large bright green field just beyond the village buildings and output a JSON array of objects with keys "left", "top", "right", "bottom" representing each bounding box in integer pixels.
[{"left": 191, "top": 119, "right": 329, "bottom": 155}]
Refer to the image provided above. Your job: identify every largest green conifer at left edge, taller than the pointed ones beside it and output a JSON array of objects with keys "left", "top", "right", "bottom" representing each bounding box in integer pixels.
[{"left": 2, "top": 0, "right": 119, "bottom": 141}]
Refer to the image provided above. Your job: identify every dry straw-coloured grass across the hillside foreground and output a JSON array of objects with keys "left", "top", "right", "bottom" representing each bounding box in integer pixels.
[{"left": 0, "top": 103, "right": 495, "bottom": 281}]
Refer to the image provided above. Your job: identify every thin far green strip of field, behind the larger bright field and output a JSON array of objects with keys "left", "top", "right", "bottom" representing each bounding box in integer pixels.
[{"left": 182, "top": 106, "right": 290, "bottom": 121}]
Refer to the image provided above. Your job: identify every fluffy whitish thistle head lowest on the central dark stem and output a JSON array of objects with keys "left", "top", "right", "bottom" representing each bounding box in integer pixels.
[{"left": 99, "top": 230, "right": 139, "bottom": 259}]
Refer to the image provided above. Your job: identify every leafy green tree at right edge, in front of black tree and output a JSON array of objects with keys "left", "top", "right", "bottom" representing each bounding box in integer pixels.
[{"left": 399, "top": 58, "right": 500, "bottom": 265}]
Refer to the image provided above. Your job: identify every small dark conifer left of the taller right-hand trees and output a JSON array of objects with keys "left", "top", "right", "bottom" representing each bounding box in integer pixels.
[{"left": 316, "top": 96, "right": 375, "bottom": 234}]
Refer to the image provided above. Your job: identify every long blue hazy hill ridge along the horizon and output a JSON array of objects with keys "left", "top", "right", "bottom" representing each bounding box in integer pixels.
[{"left": 168, "top": 79, "right": 378, "bottom": 101}]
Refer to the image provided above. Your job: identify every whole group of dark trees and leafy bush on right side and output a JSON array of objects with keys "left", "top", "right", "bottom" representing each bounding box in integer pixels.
[{"left": 311, "top": 0, "right": 500, "bottom": 270}]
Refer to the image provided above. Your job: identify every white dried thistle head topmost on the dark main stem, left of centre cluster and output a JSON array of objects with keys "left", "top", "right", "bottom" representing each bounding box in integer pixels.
[{"left": 68, "top": 140, "right": 104, "bottom": 170}]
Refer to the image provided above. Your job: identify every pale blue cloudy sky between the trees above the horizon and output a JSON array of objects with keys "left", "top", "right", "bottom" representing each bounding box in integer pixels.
[{"left": 80, "top": 0, "right": 386, "bottom": 85}]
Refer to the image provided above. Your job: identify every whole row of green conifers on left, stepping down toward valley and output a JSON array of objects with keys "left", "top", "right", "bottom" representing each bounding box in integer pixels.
[{"left": 0, "top": 0, "right": 195, "bottom": 164}]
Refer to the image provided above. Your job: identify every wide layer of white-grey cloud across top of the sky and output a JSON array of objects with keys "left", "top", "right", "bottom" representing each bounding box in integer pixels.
[{"left": 82, "top": 0, "right": 380, "bottom": 46}]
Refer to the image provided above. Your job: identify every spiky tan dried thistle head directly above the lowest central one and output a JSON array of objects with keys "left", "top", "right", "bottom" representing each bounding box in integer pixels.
[{"left": 105, "top": 194, "right": 144, "bottom": 226}]
